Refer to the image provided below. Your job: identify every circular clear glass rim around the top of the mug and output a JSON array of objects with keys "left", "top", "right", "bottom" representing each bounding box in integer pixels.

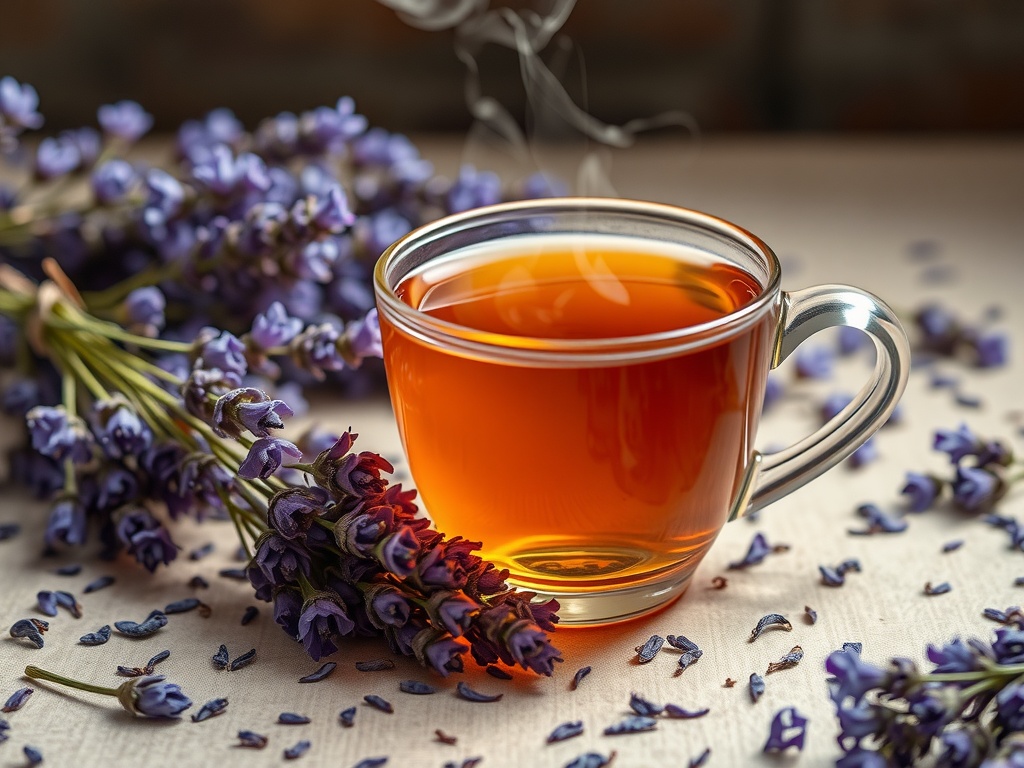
[{"left": 374, "top": 197, "right": 781, "bottom": 366}]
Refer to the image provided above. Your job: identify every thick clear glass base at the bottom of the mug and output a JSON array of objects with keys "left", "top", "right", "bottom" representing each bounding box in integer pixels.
[{"left": 508, "top": 566, "right": 695, "bottom": 627}]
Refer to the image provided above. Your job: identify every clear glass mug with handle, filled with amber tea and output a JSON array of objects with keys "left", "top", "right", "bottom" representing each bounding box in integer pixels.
[{"left": 374, "top": 198, "right": 909, "bottom": 625}]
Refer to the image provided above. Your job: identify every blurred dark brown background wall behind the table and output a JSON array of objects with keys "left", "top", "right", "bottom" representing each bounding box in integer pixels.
[{"left": 0, "top": 0, "right": 1024, "bottom": 132}]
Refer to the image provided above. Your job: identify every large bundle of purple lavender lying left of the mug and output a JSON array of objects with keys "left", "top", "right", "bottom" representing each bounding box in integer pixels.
[{"left": 0, "top": 77, "right": 561, "bottom": 675}]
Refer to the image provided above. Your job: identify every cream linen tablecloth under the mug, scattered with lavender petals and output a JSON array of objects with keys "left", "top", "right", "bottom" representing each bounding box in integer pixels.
[{"left": 0, "top": 139, "right": 1024, "bottom": 768}]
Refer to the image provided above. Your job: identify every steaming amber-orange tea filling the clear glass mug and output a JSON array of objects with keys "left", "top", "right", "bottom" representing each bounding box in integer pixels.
[{"left": 384, "top": 237, "right": 774, "bottom": 589}]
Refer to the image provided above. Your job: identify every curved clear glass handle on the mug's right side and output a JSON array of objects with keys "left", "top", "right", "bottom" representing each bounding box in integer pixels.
[{"left": 742, "top": 286, "right": 910, "bottom": 514}]
